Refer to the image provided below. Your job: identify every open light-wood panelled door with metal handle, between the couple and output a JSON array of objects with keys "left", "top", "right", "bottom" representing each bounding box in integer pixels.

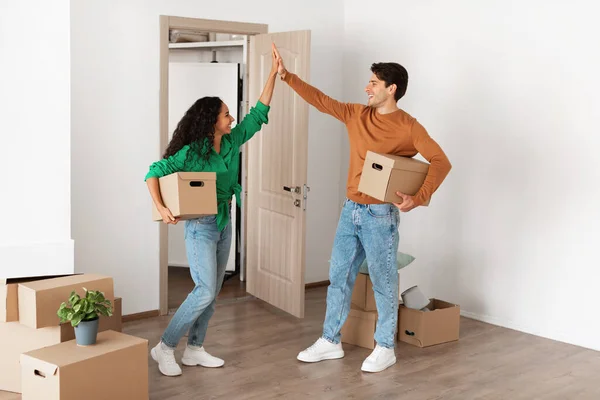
[{"left": 246, "top": 31, "right": 310, "bottom": 318}]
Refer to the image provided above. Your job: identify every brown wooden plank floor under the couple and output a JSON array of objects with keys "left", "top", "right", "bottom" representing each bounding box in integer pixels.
[{"left": 0, "top": 282, "right": 600, "bottom": 400}]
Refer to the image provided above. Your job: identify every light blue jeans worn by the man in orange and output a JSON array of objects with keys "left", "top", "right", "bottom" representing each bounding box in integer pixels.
[{"left": 323, "top": 200, "right": 400, "bottom": 348}]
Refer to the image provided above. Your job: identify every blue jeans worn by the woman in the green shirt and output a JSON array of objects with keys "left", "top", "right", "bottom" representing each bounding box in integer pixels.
[{"left": 162, "top": 215, "right": 231, "bottom": 348}]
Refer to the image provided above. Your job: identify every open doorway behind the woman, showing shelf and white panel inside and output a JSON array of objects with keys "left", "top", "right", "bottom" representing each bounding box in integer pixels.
[{"left": 168, "top": 29, "right": 248, "bottom": 312}]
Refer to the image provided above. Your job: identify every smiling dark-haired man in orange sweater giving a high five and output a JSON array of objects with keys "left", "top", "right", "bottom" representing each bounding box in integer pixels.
[{"left": 276, "top": 45, "right": 451, "bottom": 372}]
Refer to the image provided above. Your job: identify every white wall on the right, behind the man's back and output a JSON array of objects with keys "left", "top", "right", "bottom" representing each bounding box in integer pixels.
[{"left": 344, "top": 0, "right": 600, "bottom": 349}]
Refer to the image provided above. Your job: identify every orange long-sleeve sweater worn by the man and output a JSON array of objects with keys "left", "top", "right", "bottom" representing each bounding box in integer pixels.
[{"left": 284, "top": 72, "right": 452, "bottom": 205}]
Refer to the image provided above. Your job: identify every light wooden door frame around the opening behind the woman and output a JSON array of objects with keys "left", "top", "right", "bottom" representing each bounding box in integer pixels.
[{"left": 159, "top": 15, "right": 269, "bottom": 315}]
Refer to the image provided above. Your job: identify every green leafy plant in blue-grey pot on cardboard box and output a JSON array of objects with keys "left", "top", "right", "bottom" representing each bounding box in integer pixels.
[{"left": 56, "top": 288, "right": 113, "bottom": 346}]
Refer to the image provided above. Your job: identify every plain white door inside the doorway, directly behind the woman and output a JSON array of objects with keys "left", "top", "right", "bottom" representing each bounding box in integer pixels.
[{"left": 168, "top": 62, "right": 239, "bottom": 271}]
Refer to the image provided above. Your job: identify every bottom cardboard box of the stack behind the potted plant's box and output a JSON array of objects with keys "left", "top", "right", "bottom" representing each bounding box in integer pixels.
[{"left": 0, "top": 297, "right": 122, "bottom": 393}]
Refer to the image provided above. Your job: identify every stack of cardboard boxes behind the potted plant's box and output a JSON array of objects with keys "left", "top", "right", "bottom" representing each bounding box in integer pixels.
[{"left": 0, "top": 274, "right": 122, "bottom": 393}]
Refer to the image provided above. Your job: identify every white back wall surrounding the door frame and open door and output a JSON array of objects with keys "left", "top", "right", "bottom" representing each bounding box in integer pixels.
[{"left": 71, "top": 0, "right": 343, "bottom": 314}]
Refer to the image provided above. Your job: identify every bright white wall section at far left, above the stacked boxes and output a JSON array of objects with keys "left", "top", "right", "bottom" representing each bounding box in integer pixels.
[{"left": 0, "top": 0, "right": 73, "bottom": 278}]
